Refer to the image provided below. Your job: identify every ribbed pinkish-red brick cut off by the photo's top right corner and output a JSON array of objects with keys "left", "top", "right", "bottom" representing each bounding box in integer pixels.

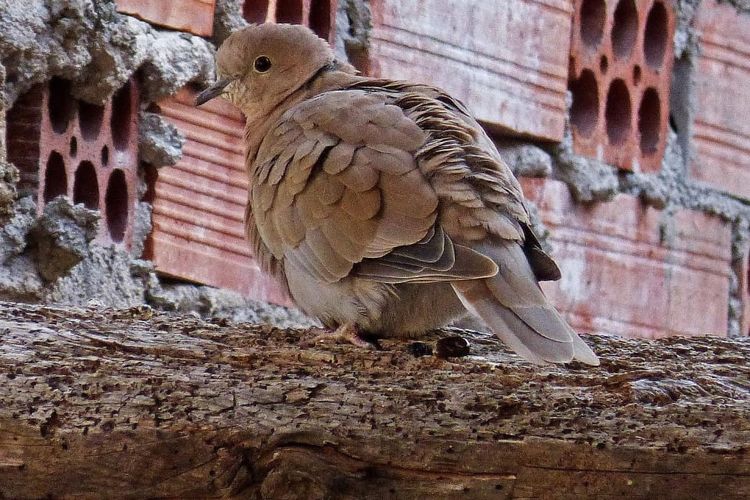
[{"left": 690, "top": 0, "right": 750, "bottom": 199}]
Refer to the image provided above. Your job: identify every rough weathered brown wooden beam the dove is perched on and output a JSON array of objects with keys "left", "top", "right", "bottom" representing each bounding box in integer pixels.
[{"left": 0, "top": 304, "right": 750, "bottom": 498}]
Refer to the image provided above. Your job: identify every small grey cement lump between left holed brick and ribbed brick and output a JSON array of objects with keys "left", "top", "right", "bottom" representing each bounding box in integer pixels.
[{"left": 138, "top": 112, "right": 185, "bottom": 167}]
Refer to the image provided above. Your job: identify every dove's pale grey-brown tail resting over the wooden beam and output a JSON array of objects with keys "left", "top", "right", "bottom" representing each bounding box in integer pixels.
[{"left": 451, "top": 241, "right": 599, "bottom": 366}]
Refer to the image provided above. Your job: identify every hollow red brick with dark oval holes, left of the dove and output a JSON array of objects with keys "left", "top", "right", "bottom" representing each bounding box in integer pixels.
[{"left": 7, "top": 78, "right": 138, "bottom": 247}]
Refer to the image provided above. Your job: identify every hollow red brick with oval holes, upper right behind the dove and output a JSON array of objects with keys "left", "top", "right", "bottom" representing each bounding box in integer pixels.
[{"left": 570, "top": 0, "right": 675, "bottom": 172}]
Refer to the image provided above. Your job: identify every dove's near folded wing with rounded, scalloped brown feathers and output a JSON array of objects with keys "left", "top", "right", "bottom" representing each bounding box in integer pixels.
[{"left": 251, "top": 90, "right": 497, "bottom": 283}]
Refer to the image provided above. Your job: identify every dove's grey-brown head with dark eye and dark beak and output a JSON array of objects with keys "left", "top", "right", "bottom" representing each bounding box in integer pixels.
[{"left": 195, "top": 23, "right": 334, "bottom": 115}]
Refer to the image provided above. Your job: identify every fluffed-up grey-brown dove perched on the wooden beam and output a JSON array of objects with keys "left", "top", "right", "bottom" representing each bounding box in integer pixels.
[{"left": 196, "top": 23, "right": 599, "bottom": 365}]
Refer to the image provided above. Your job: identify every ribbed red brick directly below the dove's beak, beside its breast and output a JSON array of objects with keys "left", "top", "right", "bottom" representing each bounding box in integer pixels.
[{"left": 146, "top": 89, "right": 290, "bottom": 305}]
